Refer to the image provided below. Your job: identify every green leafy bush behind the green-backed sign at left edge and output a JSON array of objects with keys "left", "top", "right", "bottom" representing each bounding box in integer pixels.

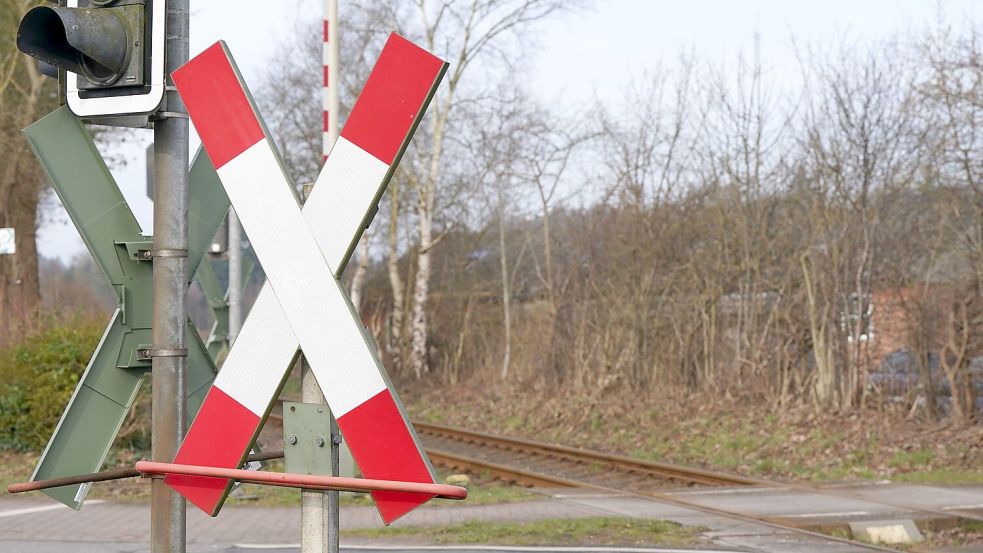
[{"left": 0, "top": 316, "right": 103, "bottom": 451}]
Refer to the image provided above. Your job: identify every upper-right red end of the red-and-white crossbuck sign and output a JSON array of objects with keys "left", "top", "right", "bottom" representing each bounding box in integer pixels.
[{"left": 341, "top": 33, "right": 446, "bottom": 165}]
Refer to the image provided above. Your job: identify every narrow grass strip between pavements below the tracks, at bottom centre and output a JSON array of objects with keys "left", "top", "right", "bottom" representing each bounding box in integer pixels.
[{"left": 343, "top": 517, "right": 705, "bottom": 547}]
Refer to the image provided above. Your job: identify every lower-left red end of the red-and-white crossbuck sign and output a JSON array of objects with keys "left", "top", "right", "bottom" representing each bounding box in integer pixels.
[{"left": 164, "top": 386, "right": 260, "bottom": 516}]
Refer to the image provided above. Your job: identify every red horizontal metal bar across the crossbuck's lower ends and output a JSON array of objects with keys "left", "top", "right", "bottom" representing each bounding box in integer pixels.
[{"left": 136, "top": 461, "right": 468, "bottom": 499}]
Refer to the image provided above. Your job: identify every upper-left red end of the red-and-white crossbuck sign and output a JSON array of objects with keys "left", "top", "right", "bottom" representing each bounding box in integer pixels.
[{"left": 171, "top": 41, "right": 263, "bottom": 169}]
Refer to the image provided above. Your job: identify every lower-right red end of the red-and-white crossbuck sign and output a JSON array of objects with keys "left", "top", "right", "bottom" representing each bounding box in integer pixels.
[{"left": 338, "top": 390, "right": 434, "bottom": 524}]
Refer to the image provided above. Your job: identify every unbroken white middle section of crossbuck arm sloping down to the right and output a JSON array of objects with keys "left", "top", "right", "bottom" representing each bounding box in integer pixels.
[{"left": 217, "top": 140, "right": 386, "bottom": 418}]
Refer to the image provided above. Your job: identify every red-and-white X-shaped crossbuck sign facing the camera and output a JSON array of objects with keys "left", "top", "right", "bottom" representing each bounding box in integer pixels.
[{"left": 165, "top": 34, "right": 447, "bottom": 524}]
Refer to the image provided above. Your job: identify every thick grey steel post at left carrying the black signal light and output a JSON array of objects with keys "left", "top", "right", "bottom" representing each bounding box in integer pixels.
[{"left": 150, "top": 0, "right": 189, "bottom": 553}]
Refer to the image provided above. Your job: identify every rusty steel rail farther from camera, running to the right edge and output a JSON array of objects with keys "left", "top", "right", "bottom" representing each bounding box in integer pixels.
[{"left": 414, "top": 422, "right": 983, "bottom": 522}]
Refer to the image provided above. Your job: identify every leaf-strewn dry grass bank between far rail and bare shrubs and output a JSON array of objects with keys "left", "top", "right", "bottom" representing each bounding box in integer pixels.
[{"left": 403, "top": 384, "right": 983, "bottom": 484}]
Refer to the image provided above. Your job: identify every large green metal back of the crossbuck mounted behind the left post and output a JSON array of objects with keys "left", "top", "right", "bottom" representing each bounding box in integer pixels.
[{"left": 24, "top": 107, "right": 229, "bottom": 510}]
